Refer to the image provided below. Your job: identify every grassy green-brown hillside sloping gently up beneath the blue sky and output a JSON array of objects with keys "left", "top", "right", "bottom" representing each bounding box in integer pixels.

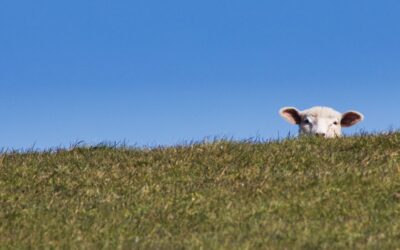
[{"left": 0, "top": 133, "right": 400, "bottom": 249}]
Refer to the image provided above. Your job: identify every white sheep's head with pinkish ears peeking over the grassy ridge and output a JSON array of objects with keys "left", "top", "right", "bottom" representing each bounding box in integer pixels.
[{"left": 279, "top": 107, "right": 364, "bottom": 138}]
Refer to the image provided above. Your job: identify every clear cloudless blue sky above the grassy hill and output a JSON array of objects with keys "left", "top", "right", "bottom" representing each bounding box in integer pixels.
[{"left": 0, "top": 0, "right": 400, "bottom": 148}]
